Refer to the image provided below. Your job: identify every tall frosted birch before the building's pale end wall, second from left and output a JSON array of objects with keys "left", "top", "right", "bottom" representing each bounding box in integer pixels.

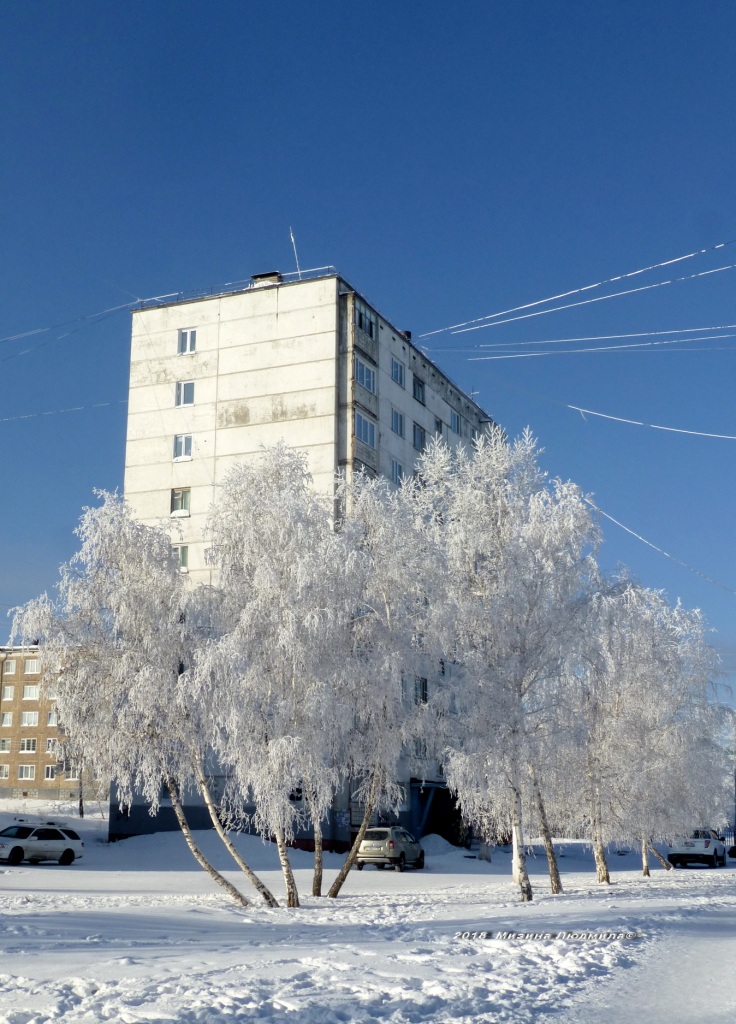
[{"left": 197, "top": 445, "right": 357, "bottom": 906}]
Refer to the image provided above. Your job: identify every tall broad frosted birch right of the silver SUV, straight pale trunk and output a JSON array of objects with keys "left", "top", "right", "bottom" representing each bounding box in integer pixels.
[{"left": 421, "top": 430, "right": 597, "bottom": 900}]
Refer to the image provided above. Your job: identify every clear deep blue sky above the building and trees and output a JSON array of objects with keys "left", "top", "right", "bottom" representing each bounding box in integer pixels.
[{"left": 0, "top": 0, "right": 736, "bottom": 688}]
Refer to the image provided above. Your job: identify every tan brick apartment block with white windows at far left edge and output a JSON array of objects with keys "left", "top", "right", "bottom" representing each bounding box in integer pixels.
[{"left": 0, "top": 647, "right": 79, "bottom": 800}]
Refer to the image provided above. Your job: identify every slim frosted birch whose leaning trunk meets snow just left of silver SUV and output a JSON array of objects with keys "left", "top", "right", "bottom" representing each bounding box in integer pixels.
[{"left": 329, "top": 475, "right": 444, "bottom": 897}]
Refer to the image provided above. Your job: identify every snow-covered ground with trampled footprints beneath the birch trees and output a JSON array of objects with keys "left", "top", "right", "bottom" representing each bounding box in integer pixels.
[{"left": 0, "top": 804, "right": 736, "bottom": 1024}]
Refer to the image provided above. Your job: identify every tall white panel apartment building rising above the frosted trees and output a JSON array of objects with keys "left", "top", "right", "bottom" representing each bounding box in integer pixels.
[{"left": 125, "top": 267, "right": 491, "bottom": 583}]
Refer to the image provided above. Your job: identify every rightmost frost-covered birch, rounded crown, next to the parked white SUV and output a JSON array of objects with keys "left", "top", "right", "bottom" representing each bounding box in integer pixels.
[{"left": 568, "top": 577, "right": 727, "bottom": 882}]
